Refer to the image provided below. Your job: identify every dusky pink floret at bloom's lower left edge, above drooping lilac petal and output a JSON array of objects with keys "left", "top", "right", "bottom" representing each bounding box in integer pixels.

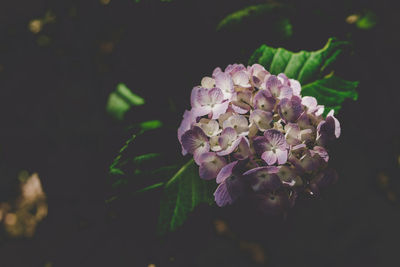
[{"left": 198, "top": 152, "right": 226, "bottom": 180}]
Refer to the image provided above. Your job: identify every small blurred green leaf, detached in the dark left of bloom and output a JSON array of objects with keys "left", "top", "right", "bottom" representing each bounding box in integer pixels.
[{"left": 106, "top": 83, "right": 145, "bottom": 120}]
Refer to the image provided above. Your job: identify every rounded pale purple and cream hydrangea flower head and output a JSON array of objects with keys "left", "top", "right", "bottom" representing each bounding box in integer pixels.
[{"left": 178, "top": 64, "right": 340, "bottom": 216}]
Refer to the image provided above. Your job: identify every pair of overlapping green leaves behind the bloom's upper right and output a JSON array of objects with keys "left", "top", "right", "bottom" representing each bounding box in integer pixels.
[{"left": 249, "top": 38, "right": 358, "bottom": 114}]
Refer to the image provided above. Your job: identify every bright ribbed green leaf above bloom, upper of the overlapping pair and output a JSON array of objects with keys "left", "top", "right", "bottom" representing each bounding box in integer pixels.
[{"left": 249, "top": 38, "right": 348, "bottom": 84}]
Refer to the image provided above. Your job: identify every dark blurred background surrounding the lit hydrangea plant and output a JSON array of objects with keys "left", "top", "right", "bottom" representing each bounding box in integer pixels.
[{"left": 0, "top": 0, "right": 400, "bottom": 267}]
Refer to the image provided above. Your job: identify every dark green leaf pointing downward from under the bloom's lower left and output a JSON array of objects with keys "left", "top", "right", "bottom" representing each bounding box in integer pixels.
[{"left": 158, "top": 159, "right": 216, "bottom": 234}]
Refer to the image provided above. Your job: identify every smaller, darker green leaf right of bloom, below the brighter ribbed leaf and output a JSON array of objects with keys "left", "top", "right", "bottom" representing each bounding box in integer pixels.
[{"left": 301, "top": 76, "right": 359, "bottom": 114}]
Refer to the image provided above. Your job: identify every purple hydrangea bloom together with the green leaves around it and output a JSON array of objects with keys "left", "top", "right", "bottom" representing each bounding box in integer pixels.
[{"left": 107, "top": 38, "right": 358, "bottom": 234}]
